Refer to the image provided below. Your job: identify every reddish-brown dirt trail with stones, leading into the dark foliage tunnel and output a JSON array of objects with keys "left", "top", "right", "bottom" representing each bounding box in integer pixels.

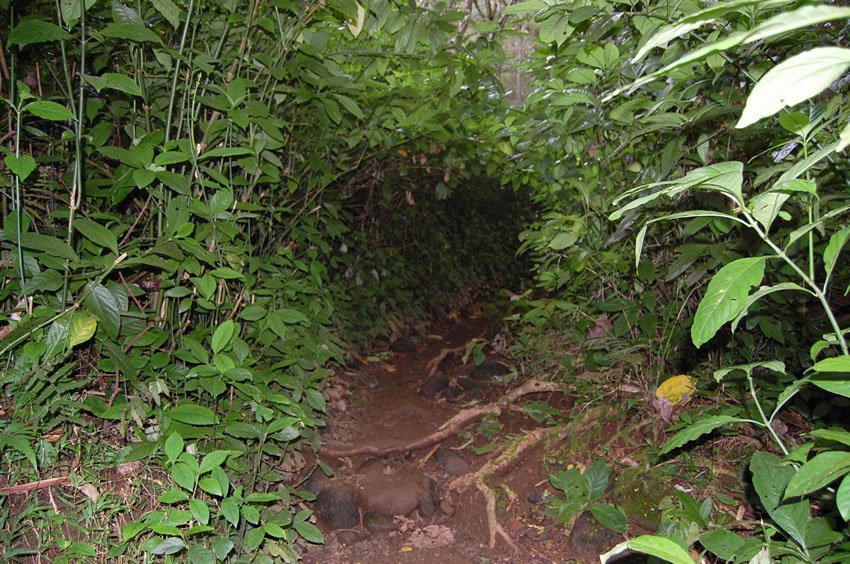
[{"left": 305, "top": 319, "right": 574, "bottom": 564}]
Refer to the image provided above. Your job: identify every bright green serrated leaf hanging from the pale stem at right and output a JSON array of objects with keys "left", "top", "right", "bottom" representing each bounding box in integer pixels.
[{"left": 691, "top": 257, "right": 768, "bottom": 348}]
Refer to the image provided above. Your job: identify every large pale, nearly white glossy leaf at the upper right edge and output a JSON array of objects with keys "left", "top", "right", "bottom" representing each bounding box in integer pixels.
[{"left": 735, "top": 47, "right": 850, "bottom": 129}]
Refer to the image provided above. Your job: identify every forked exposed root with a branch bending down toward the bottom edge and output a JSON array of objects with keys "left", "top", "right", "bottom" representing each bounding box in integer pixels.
[{"left": 449, "top": 427, "right": 566, "bottom": 552}]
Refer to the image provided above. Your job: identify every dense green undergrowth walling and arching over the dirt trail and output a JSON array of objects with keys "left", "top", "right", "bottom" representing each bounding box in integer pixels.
[{"left": 0, "top": 0, "right": 850, "bottom": 562}]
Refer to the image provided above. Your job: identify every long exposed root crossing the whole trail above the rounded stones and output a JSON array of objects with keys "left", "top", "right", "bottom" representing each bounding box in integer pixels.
[{"left": 319, "top": 378, "right": 563, "bottom": 458}]
